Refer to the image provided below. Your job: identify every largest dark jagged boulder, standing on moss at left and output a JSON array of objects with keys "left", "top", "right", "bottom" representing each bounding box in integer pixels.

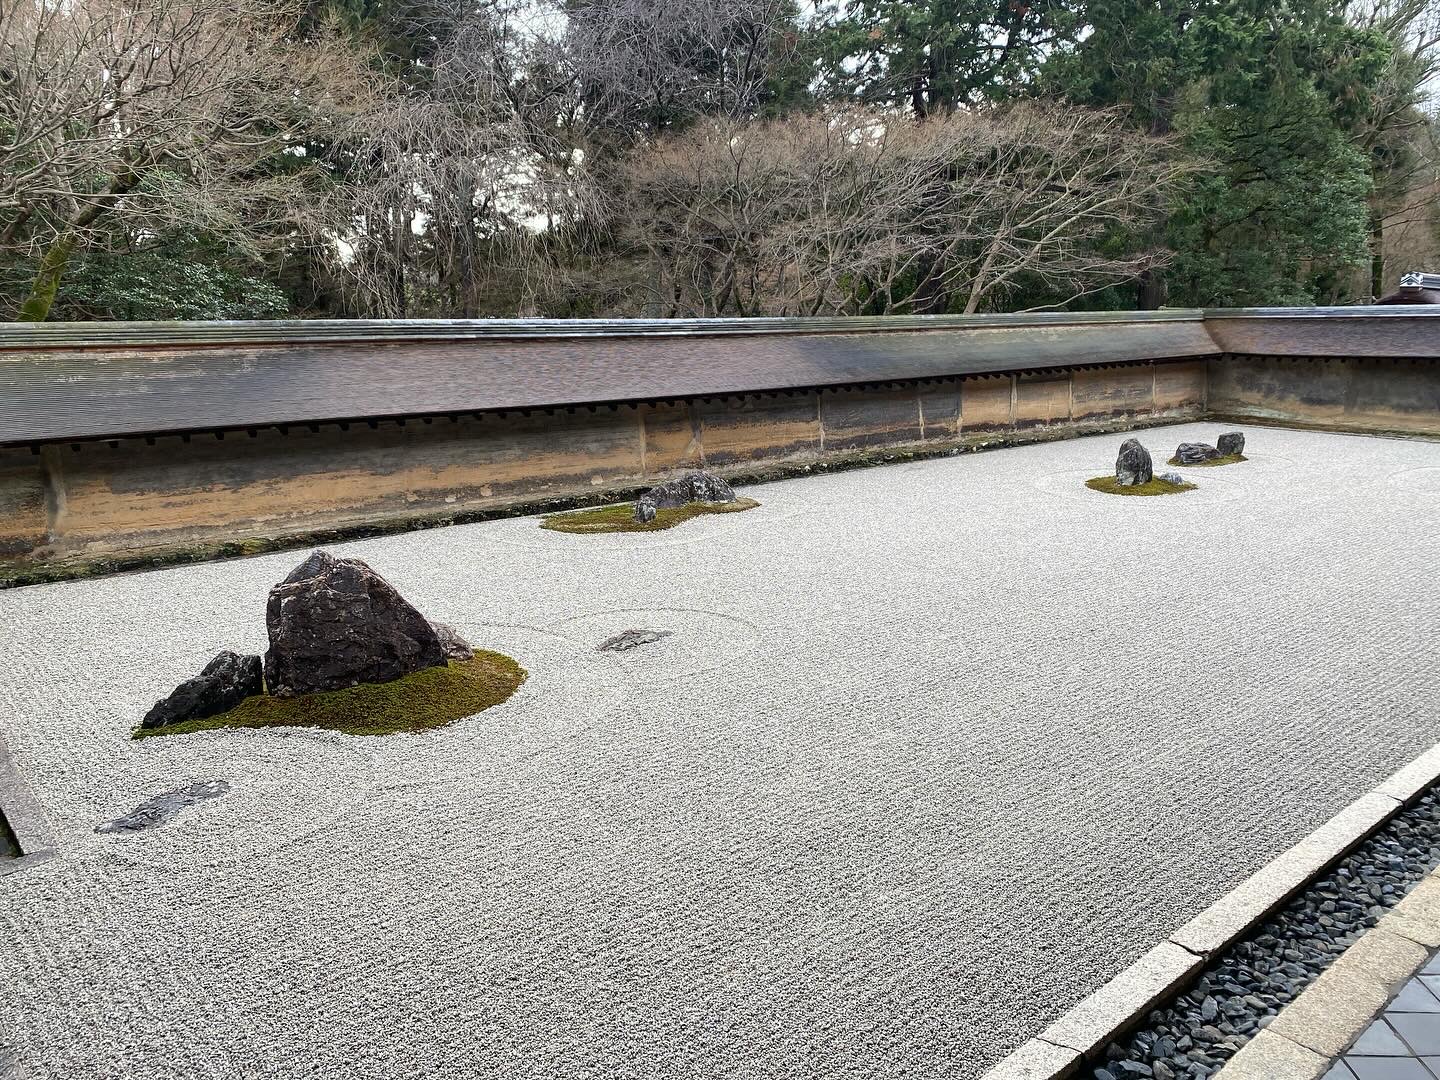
[{"left": 265, "top": 552, "right": 445, "bottom": 697}]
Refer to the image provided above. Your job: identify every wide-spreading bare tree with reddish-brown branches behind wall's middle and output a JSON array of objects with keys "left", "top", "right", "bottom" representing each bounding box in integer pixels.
[{"left": 629, "top": 105, "right": 1194, "bottom": 315}]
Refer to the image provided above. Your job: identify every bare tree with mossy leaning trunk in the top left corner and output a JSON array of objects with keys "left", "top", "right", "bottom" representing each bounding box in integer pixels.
[{"left": 0, "top": 0, "right": 342, "bottom": 320}]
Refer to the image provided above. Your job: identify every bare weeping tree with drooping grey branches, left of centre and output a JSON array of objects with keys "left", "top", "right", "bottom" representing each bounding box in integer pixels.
[{"left": 312, "top": 0, "right": 600, "bottom": 317}]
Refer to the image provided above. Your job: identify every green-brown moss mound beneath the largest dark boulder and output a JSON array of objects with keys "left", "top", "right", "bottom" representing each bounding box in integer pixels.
[{"left": 134, "top": 649, "right": 527, "bottom": 739}]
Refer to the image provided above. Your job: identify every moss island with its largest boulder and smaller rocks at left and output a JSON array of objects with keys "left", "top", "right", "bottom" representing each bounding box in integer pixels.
[{"left": 135, "top": 552, "right": 526, "bottom": 737}]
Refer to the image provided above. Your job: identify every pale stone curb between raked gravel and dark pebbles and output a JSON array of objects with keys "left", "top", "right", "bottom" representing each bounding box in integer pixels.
[{"left": 984, "top": 744, "right": 1440, "bottom": 1080}]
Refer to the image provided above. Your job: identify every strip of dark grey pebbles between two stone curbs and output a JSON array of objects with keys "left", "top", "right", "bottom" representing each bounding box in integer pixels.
[{"left": 1090, "top": 793, "right": 1440, "bottom": 1080}]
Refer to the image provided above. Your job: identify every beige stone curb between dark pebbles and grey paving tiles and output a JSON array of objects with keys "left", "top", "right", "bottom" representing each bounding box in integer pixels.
[{"left": 1215, "top": 870, "right": 1440, "bottom": 1080}]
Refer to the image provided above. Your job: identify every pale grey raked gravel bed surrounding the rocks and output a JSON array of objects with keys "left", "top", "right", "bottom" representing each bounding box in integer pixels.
[{"left": 0, "top": 425, "right": 1440, "bottom": 1080}]
